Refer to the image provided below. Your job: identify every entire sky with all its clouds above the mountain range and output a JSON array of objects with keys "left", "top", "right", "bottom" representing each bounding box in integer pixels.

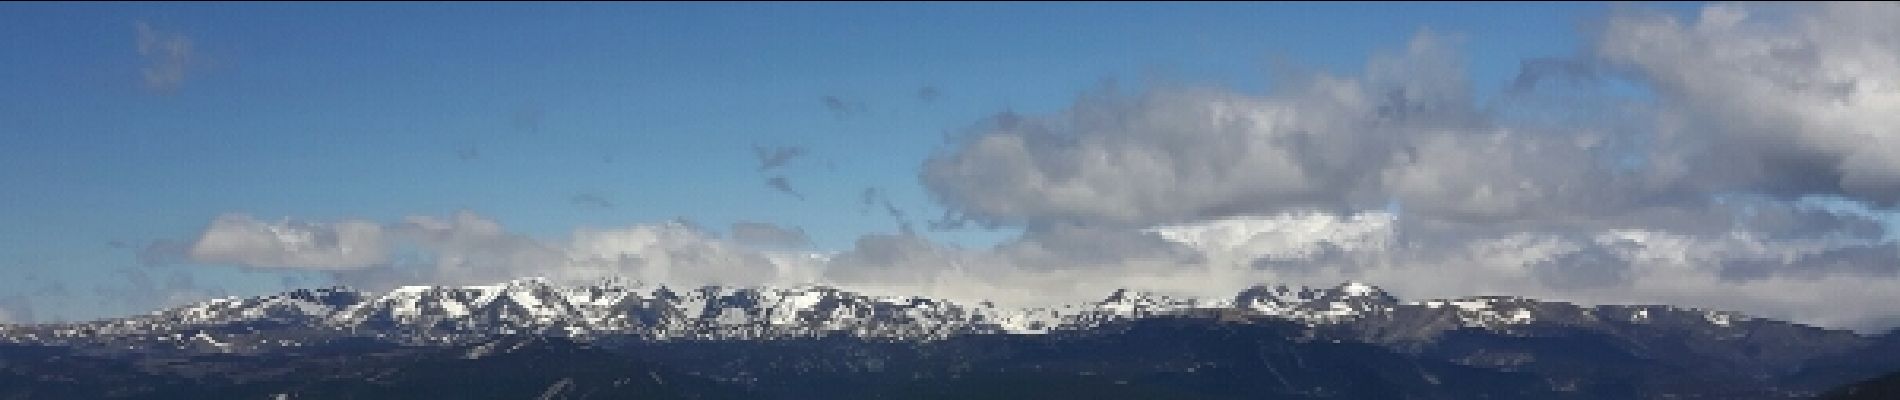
[{"left": 0, "top": 2, "right": 1900, "bottom": 332}]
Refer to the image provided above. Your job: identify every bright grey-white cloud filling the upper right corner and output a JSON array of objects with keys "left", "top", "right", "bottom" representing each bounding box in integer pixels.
[{"left": 1596, "top": 2, "right": 1900, "bottom": 205}]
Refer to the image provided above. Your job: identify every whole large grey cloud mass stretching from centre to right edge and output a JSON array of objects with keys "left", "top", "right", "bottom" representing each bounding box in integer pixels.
[{"left": 920, "top": 4, "right": 1900, "bottom": 227}]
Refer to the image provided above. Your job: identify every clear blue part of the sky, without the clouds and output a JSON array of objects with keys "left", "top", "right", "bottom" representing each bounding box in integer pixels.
[{"left": 22, "top": 2, "right": 1900, "bottom": 327}]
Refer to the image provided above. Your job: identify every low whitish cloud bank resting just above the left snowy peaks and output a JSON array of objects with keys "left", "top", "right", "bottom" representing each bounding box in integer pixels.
[{"left": 176, "top": 210, "right": 821, "bottom": 292}]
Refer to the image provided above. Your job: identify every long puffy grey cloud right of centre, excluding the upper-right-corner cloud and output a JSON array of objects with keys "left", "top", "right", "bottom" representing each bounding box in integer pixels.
[{"left": 922, "top": 34, "right": 1542, "bottom": 227}]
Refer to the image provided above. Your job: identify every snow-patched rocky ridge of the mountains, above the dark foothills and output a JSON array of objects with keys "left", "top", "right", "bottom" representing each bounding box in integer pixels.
[{"left": 0, "top": 279, "right": 1801, "bottom": 351}]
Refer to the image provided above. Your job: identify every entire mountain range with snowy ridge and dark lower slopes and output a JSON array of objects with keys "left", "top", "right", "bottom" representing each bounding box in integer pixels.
[{"left": 0, "top": 279, "right": 1900, "bottom": 398}]
